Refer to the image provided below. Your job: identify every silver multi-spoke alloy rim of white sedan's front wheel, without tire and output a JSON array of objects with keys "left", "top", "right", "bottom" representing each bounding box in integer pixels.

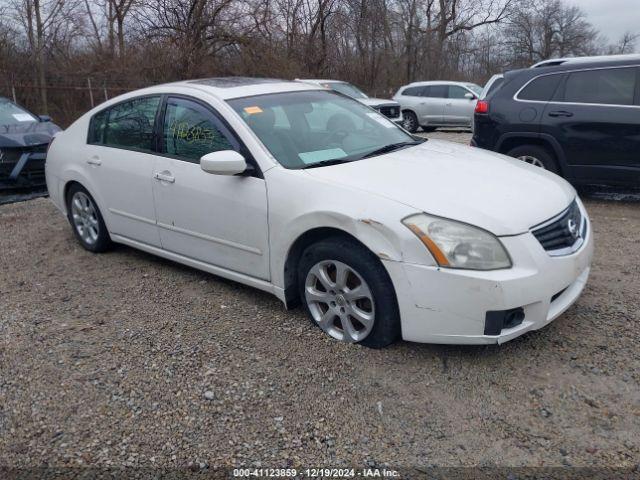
[{"left": 304, "top": 260, "right": 375, "bottom": 342}]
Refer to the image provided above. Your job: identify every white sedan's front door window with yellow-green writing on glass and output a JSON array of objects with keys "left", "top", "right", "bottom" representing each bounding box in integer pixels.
[{"left": 162, "top": 97, "right": 236, "bottom": 163}]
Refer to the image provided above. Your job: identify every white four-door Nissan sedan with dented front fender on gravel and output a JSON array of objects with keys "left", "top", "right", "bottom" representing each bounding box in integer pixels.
[{"left": 46, "top": 78, "right": 593, "bottom": 347}]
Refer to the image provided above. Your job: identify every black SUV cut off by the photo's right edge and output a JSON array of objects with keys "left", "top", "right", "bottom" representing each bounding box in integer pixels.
[{"left": 471, "top": 55, "right": 640, "bottom": 186}]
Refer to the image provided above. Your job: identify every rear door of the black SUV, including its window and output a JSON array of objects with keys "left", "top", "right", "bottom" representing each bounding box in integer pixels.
[{"left": 541, "top": 67, "right": 640, "bottom": 183}]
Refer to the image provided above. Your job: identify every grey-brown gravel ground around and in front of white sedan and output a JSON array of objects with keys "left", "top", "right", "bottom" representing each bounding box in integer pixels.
[{"left": 0, "top": 134, "right": 640, "bottom": 468}]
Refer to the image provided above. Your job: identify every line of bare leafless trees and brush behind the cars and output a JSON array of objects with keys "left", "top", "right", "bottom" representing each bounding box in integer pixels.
[{"left": 0, "top": 0, "right": 637, "bottom": 124}]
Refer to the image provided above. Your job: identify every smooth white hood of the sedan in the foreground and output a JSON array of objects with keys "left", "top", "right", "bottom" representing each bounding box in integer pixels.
[{"left": 306, "top": 140, "right": 576, "bottom": 236}]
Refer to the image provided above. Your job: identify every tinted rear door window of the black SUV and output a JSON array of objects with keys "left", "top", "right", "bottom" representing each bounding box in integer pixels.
[{"left": 564, "top": 68, "right": 636, "bottom": 105}]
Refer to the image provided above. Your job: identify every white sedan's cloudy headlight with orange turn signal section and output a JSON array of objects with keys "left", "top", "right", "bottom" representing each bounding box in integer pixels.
[{"left": 402, "top": 213, "right": 511, "bottom": 270}]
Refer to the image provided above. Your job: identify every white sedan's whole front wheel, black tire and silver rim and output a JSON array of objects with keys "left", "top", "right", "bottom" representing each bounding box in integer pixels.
[{"left": 298, "top": 237, "right": 400, "bottom": 348}]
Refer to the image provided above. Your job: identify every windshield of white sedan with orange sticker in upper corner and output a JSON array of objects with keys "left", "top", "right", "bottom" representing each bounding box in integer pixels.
[{"left": 228, "top": 90, "right": 424, "bottom": 169}]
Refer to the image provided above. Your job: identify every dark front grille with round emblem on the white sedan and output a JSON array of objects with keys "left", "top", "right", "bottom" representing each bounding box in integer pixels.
[{"left": 531, "top": 200, "right": 587, "bottom": 255}]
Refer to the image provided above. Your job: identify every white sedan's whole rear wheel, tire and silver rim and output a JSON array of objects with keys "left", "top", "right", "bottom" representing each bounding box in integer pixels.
[{"left": 67, "top": 183, "right": 112, "bottom": 253}]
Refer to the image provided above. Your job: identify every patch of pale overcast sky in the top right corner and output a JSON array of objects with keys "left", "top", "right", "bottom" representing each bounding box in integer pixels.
[{"left": 567, "top": 0, "right": 640, "bottom": 43}]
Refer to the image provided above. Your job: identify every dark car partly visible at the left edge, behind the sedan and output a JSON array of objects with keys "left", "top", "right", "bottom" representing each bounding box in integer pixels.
[{"left": 0, "top": 97, "right": 60, "bottom": 189}]
